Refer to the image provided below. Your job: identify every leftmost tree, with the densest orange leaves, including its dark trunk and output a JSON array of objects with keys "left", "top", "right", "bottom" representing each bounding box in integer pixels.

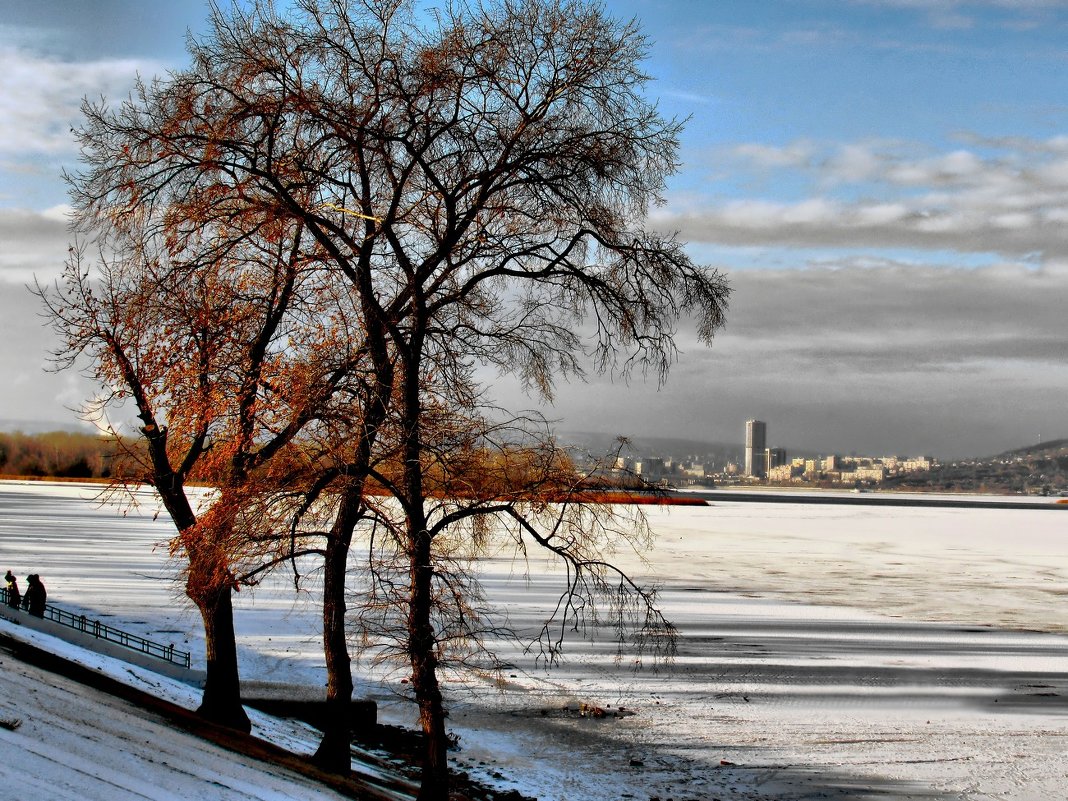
[{"left": 37, "top": 214, "right": 359, "bottom": 729}]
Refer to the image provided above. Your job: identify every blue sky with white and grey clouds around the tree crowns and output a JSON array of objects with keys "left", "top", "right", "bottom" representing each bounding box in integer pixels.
[{"left": 0, "top": 0, "right": 1068, "bottom": 458}]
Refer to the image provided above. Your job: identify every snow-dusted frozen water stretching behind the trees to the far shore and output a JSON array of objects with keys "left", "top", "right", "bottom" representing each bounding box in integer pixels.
[{"left": 0, "top": 483, "right": 1068, "bottom": 801}]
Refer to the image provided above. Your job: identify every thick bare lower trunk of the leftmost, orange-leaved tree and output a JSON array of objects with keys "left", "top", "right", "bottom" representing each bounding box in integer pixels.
[{"left": 190, "top": 586, "right": 252, "bottom": 733}]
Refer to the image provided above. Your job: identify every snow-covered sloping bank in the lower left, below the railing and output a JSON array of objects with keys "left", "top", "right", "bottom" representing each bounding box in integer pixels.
[{"left": 0, "top": 622, "right": 358, "bottom": 801}]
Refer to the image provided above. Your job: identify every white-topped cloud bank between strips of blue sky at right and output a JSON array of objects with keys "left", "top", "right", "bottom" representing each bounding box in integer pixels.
[{"left": 653, "top": 138, "right": 1068, "bottom": 261}]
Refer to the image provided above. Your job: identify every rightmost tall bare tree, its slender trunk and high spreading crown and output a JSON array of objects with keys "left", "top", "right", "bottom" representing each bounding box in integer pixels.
[{"left": 294, "top": 0, "right": 726, "bottom": 799}]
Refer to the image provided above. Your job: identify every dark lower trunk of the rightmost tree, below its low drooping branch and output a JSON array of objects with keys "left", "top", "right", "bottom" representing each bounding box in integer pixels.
[{"left": 408, "top": 521, "right": 449, "bottom": 801}]
